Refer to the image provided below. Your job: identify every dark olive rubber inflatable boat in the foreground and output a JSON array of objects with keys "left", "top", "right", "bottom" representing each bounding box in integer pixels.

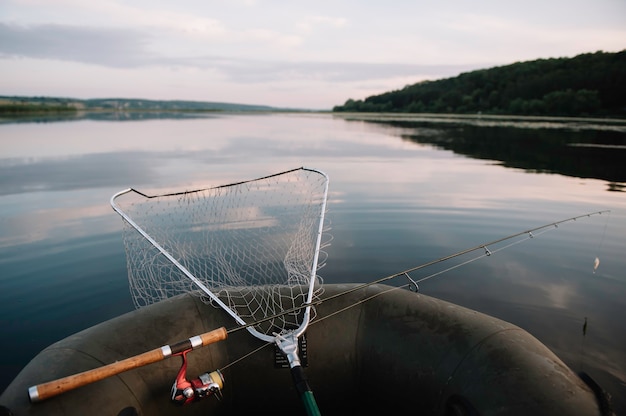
[{"left": 0, "top": 284, "right": 603, "bottom": 416}]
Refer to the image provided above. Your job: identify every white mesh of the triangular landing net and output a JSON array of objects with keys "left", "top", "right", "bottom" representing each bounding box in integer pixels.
[{"left": 114, "top": 168, "right": 328, "bottom": 334}]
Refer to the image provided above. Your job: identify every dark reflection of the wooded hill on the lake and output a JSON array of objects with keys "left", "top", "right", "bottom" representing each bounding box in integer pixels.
[{"left": 336, "top": 114, "right": 626, "bottom": 184}]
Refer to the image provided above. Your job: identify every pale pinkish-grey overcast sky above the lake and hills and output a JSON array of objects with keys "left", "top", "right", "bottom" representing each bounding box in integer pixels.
[{"left": 0, "top": 0, "right": 626, "bottom": 109}]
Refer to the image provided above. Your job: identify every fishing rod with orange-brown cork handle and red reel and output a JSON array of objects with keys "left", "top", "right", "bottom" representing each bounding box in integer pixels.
[{"left": 28, "top": 210, "right": 611, "bottom": 404}]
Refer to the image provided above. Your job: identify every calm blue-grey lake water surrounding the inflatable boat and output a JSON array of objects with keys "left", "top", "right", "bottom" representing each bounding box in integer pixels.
[{"left": 0, "top": 114, "right": 626, "bottom": 414}]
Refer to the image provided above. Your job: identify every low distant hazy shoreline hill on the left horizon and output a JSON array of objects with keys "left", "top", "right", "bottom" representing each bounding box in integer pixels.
[{"left": 0, "top": 96, "right": 279, "bottom": 114}]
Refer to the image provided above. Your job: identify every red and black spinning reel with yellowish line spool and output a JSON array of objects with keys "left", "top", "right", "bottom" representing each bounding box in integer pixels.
[{"left": 172, "top": 349, "right": 224, "bottom": 406}]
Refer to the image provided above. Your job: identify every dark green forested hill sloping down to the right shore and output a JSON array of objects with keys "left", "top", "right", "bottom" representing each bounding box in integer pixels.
[{"left": 333, "top": 50, "right": 626, "bottom": 117}]
